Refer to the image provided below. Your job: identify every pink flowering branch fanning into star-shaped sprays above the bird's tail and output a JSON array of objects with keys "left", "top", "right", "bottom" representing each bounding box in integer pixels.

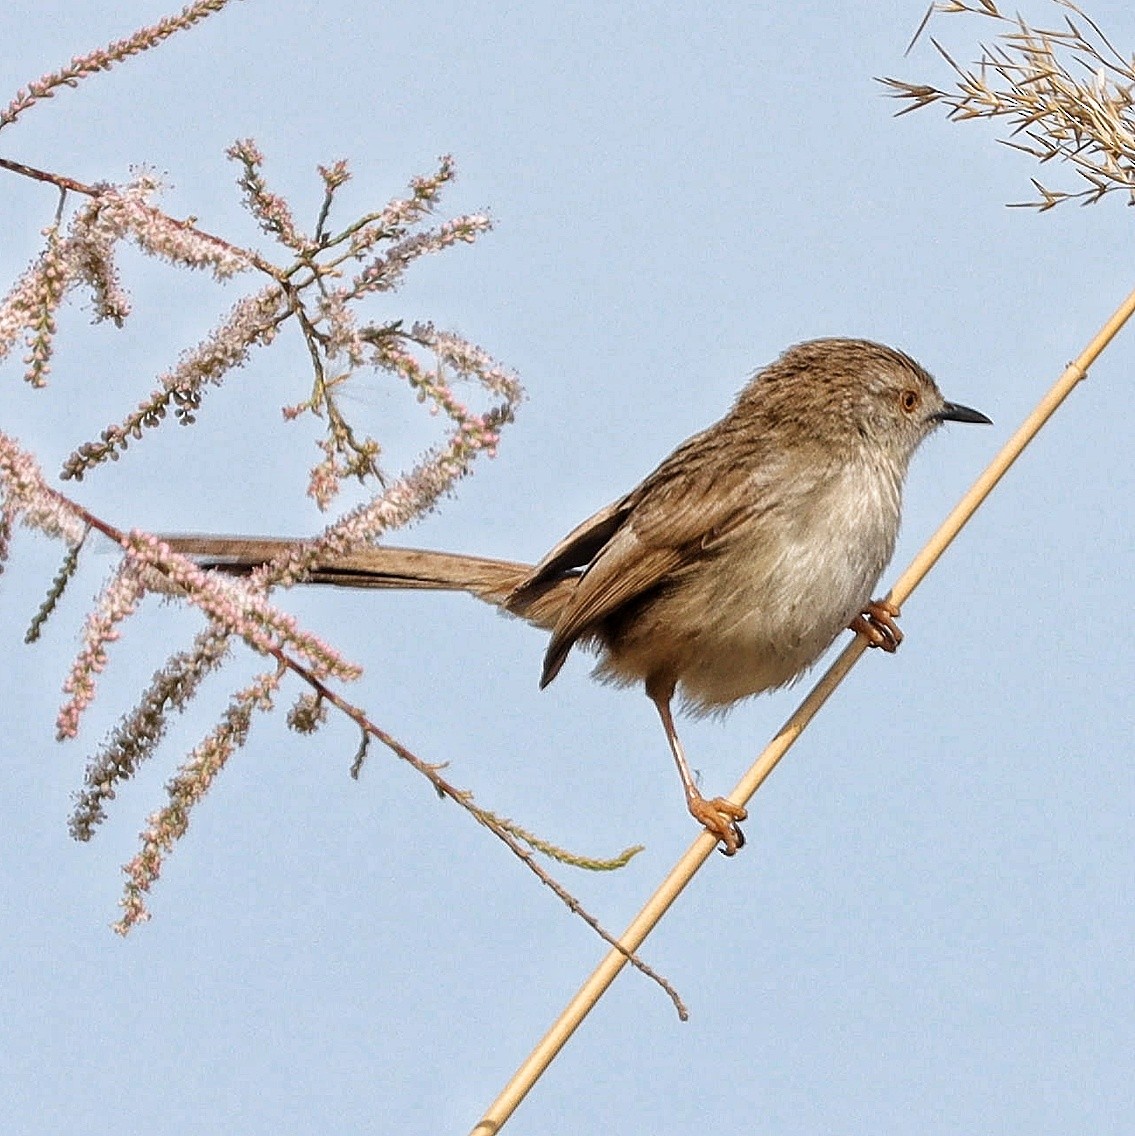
[{"left": 0, "top": 140, "right": 521, "bottom": 509}]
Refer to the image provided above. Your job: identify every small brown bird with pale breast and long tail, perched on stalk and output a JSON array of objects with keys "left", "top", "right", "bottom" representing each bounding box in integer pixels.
[{"left": 164, "top": 339, "right": 990, "bottom": 855}]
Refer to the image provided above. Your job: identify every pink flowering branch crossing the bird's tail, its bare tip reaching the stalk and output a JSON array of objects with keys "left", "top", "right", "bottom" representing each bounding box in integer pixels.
[{"left": 0, "top": 432, "right": 645, "bottom": 972}]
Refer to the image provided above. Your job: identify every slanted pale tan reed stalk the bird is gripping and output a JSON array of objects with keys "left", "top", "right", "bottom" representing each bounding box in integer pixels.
[{"left": 473, "top": 292, "right": 1135, "bottom": 1136}]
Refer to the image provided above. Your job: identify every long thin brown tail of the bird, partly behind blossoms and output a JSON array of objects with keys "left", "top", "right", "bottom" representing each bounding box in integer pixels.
[{"left": 159, "top": 534, "right": 578, "bottom": 630}]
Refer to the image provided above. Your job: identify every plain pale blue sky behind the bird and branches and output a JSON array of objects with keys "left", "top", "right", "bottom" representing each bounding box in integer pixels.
[{"left": 0, "top": 0, "right": 1135, "bottom": 1136}]
